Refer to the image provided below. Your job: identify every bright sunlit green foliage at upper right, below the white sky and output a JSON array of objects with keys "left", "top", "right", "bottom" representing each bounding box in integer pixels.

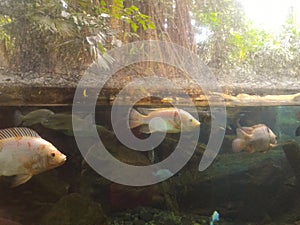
[{"left": 193, "top": 0, "right": 300, "bottom": 75}]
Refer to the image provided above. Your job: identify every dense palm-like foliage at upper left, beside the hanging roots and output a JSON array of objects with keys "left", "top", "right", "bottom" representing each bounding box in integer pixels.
[{"left": 0, "top": 0, "right": 155, "bottom": 72}]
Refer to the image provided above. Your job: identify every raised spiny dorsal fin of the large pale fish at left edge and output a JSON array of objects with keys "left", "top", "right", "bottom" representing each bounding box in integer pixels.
[{"left": 0, "top": 127, "right": 40, "bottom": 139}]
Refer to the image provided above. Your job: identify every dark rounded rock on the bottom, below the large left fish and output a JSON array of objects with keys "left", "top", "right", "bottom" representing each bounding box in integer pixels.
[{"left": 41, "top": 193, "right": 107, "bottom": 225}]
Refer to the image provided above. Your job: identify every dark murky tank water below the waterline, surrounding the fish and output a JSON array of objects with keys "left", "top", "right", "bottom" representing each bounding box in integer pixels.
[{"left": 0, "top": 105, "right": 300, "bottom": 225}]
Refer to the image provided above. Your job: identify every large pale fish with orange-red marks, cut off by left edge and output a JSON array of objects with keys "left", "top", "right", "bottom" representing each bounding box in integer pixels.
[{"left": 0, "top": 127, "right": 67, "bottom": 187}]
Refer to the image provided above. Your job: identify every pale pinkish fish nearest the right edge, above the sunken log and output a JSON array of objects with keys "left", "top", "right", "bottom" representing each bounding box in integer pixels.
[{"left": 232, "top": 124, "right": 279, "bottom": 153}]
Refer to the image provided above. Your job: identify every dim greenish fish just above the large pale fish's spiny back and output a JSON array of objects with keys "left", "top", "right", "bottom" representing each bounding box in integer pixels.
[{"left": 14, "top": 109, "right": 54, "bottom": 126}]
